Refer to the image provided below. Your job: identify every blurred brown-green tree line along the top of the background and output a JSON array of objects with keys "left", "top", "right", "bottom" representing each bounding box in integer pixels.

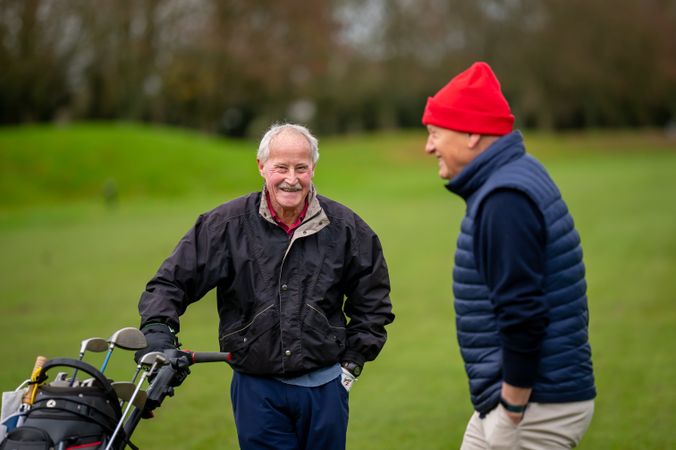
[{"left": 0, "top": 0, "right": 676, "bottom": 136}]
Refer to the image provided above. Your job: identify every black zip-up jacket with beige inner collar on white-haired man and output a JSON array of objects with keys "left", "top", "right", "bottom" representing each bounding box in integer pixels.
[{"left": 139, "top": 188, "right": 394, "bottom": 376}]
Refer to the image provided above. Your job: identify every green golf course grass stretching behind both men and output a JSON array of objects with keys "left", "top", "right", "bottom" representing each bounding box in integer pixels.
[{"left": 0, "top": 124, "right": 676, "bottom": 450}]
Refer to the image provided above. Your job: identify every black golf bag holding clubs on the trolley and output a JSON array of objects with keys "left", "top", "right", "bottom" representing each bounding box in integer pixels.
[{"left": 0, "top": 358, "right": 123, "bottom": 450}]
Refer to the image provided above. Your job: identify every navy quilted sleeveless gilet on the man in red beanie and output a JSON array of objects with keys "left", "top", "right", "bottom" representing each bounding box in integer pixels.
[{"left": 447, "top": 131, "right": 596, "bottom": 412}]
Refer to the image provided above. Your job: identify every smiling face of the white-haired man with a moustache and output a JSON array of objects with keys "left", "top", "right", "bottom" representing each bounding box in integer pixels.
[{"left": 258, "top": 129, "right": 314, "bottom": 220}]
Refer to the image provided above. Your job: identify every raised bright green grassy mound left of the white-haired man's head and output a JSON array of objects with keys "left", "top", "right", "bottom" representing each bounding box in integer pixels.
[{"left": 0, "top": 123, "right": 258, "bottom": 206}]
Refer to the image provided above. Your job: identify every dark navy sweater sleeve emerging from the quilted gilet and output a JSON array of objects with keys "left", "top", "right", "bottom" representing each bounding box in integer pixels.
[{"left": 474, "top": 189, "right": 548, "bottom": 387}]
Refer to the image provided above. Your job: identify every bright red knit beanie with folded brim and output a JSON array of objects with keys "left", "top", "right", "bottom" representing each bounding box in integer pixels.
[{"left": 422, "top": 62, "right": 514, "bottom": 136}]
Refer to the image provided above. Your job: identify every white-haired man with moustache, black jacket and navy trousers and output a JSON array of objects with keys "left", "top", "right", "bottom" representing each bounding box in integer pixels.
[{"left": 139, "top": 124, "right": 394, "bottom": 449}]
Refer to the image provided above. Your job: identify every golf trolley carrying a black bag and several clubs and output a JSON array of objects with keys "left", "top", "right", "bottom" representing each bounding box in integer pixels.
[{"left": 0, "top": 327, "right": 230, "bottom": 450}]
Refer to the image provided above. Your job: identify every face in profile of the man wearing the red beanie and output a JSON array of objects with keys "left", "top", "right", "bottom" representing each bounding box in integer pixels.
[{"left": 425, "top": 125, "right": 479, "bottom": 180}]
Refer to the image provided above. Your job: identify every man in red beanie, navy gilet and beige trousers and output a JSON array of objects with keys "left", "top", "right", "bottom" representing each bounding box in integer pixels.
[{"left": 422, "top": 62, "right": 596, "bottom": 449}]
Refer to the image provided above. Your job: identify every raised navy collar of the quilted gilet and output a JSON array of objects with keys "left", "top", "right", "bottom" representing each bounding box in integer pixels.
[{"left": 446, "top": 131, "right": 526, "bottom": 200}]
